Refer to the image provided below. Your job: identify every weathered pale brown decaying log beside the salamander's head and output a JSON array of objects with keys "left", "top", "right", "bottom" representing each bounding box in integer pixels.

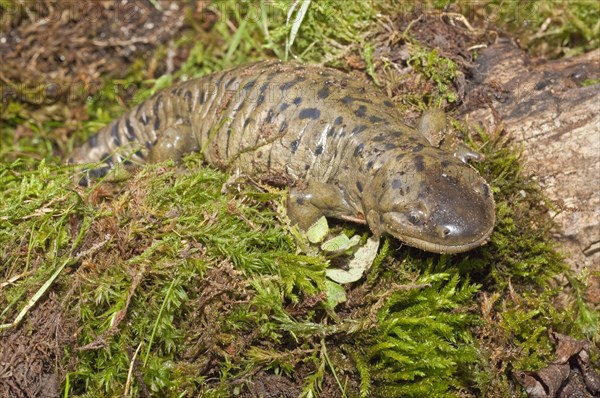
[{"left": 463, "top": 39, "right": 600, "bottom": 290}]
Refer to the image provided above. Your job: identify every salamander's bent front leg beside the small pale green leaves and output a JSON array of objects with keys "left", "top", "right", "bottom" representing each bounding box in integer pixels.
[{"left": 287, "top": 181, "right": 364, "bottom": 230}]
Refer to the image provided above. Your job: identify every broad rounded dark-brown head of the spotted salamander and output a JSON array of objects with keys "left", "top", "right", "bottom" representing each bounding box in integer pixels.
[{"left": 363, "top": 148, "right": 495, "bottom": 253}]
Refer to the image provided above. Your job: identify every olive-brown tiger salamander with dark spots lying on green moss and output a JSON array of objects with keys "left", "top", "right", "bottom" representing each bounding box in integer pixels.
[{"left": 69, "top": 61, "right": 495, "bottom": 253}]
